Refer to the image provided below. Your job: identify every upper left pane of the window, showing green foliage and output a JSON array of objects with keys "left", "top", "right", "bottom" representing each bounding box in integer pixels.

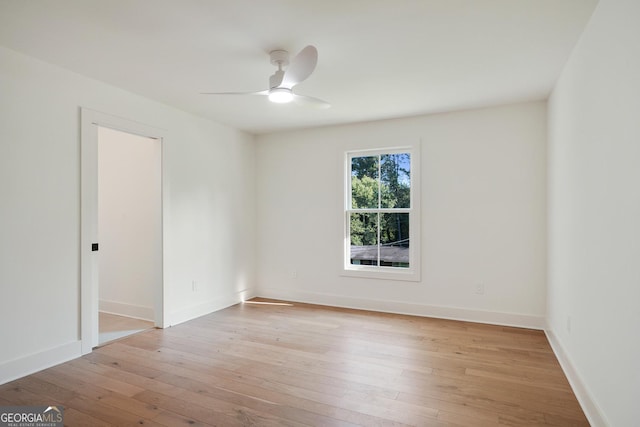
[{"left": 351, "top": 156, "right": 379, "bottom": 209}]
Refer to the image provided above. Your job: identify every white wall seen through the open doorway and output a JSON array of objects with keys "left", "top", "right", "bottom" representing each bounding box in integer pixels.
[{"left": 98, "top": 127, "right": 162, "bottom": 321}]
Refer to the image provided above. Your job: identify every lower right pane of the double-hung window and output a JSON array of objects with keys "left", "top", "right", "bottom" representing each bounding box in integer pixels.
[{"left": 380, "top": 213, "right": 409, "bottom": 268}]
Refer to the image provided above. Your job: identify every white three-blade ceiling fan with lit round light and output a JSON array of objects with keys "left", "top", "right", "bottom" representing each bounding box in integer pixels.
[{"left": 202, "top": 45, "right": 331, "bottom": 108}]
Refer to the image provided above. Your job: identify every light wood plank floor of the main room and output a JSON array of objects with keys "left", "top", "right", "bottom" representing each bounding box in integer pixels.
[{"left": 0, "top": 300, "right": 588, "bottom": 426}]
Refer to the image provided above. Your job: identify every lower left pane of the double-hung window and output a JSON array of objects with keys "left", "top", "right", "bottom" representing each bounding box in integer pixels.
[{"left": 349, "top": 213, "right": 378, "bottom": 265}]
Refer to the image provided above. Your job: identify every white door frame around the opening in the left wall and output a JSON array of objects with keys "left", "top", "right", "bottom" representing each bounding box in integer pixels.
[{"left": 80, "top": 108, "right": 167, "bottom": 354}]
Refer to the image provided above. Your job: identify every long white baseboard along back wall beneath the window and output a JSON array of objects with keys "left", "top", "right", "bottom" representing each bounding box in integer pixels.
[{"left": 258, "top": 288, "right": 545, "bottom": 330}]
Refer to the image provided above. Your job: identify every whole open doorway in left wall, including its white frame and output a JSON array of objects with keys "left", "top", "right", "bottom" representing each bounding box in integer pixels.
[{"left": 80, "top": 108, "right": 164, "bottom": 354}]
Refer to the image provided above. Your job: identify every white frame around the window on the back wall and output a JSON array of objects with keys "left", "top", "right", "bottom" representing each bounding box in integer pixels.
[{"left": 342, "top": 143, "right": 421, "bottom": 282}]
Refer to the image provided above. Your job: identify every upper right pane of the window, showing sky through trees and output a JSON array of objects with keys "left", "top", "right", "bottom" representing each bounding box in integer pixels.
[{"left": 380, "top": 153, "right": 411, "bottom": 208}]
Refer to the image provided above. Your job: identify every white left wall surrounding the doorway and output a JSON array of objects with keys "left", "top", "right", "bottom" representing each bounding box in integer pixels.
[{"left": 0, "top": 48, "right": 255, "bottom": 383}]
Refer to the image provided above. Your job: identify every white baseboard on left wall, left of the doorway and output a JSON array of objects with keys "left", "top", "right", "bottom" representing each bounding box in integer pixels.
[{"left": 0, "top": 341, "right": 82, "bottom": 384}]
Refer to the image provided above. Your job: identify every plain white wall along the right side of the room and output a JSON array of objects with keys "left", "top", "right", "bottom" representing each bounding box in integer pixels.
[{"left": 548, "top": 0, "right": 640, "bottom": 426}]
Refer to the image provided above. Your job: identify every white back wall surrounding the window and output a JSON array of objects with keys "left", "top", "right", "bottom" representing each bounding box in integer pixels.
[{"left": 256, "top": 102, "right": 546, "bottom": 328}]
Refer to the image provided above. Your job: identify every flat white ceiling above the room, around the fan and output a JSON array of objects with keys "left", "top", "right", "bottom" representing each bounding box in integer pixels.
[{"left": 0, "top": 0, "right": 597, "bottom": 133}]
